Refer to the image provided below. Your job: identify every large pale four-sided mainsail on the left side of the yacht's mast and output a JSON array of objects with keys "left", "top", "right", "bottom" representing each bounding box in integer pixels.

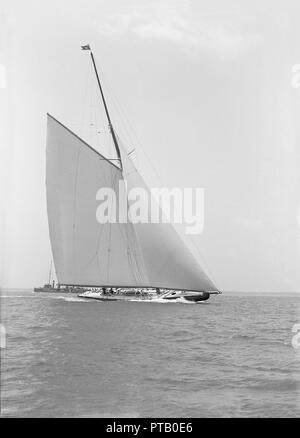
[{"left": 46, "top": 115, "right": 149, "bottom": 286}]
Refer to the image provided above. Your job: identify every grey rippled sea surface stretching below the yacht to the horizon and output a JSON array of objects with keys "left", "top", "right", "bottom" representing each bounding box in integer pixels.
[{"left": 1, "top": 290, "right": 300, "bottom": 417}]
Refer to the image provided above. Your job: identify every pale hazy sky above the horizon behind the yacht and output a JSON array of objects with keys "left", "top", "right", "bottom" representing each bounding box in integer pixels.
[{"left": 0, "top": 0, "right": 300, "bottom": 291}]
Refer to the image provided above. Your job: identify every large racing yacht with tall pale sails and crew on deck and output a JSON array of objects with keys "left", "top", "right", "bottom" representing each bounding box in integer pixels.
[{"left": 46, "top": 45, "right": 220, "bottom": 302}]
